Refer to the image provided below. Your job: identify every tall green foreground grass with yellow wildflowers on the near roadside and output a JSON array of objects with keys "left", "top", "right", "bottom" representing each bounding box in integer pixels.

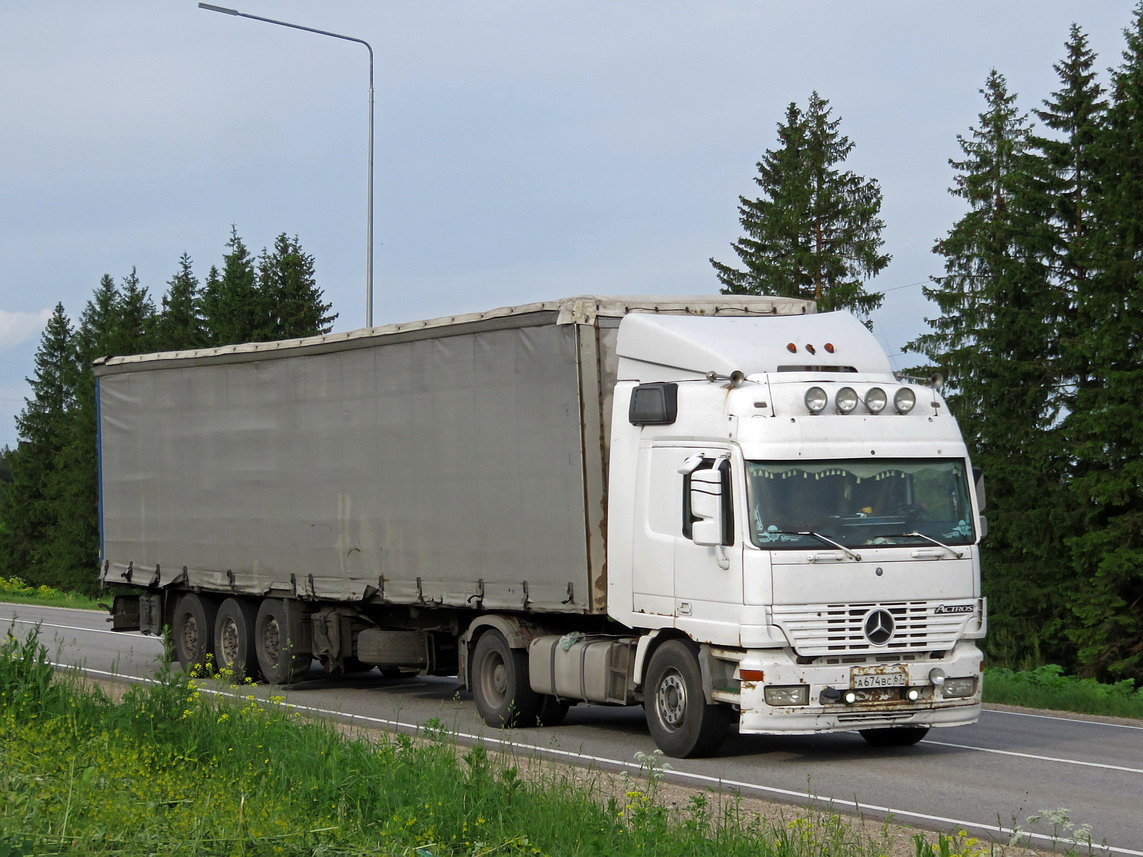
[{"left": 0, "top": 632, "right": 986, "bottom": 857}]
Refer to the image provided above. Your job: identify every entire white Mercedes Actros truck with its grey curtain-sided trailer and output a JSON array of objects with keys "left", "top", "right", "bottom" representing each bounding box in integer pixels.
[{"left": 96, "top": 296, "right": 985, "bottom": 756}]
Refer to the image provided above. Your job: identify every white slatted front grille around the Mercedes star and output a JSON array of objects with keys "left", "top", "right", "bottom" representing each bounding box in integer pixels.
[{"left": 773, "top": 601, "right": 974, "bottom": 657}]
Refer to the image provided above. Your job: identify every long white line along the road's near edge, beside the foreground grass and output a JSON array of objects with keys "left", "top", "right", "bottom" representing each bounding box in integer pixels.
[{"left": 51, "top": 667, "right": 1143, "bottom": 857}]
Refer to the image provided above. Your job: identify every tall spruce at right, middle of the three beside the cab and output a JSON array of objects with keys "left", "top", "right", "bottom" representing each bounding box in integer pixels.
[{"left": 989, "top": 25, "right": 1106, "bottom": 670}]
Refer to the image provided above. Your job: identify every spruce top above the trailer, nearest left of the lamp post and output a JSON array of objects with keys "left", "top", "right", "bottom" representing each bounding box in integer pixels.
[{"left": 258, "top": 232, "right": 337, "bottom": 339}]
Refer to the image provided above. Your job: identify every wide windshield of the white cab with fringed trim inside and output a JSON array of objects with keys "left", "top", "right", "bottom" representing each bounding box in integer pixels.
[{"left": 746, "top": 458, "right": 976, "bottom": 550}]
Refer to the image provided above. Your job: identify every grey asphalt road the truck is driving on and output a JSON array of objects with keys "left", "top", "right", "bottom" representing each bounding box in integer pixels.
[{"left": 8, "top": 604, "right": 1143, "bottom": 857}]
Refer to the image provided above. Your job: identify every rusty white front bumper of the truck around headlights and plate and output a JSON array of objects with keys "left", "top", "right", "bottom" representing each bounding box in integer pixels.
[{"left": 737, "top": 642, "right": 983, "bottom": 735}]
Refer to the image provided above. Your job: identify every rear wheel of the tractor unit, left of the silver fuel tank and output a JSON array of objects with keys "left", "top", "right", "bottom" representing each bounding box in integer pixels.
[{"left": 472, "top": 631, "right": 541, "bottom": 729}]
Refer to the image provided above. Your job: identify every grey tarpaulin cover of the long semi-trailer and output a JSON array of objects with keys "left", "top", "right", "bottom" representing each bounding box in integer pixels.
[{"left": 96, "top": 296, "right": 813, "bottom": 614}]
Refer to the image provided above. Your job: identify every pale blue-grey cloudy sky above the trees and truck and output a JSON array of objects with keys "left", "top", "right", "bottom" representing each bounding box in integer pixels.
[{"left": 0, "top": 0, "right": 1134, "bottom": 446}]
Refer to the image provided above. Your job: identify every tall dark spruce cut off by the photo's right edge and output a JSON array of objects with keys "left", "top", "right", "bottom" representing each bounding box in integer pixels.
[{"left": 1065, "top": 3, "right": 1143, "bottom": 680}]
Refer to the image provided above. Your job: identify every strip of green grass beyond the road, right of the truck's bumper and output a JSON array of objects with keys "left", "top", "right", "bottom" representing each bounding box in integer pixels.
[{"left": 984, "top": 664, "right": 1143, "bottom": 719}]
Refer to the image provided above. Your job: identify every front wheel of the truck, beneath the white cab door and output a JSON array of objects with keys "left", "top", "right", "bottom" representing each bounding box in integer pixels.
[{"left": 644, "top": 640, "right": 730, "bottom": 759}]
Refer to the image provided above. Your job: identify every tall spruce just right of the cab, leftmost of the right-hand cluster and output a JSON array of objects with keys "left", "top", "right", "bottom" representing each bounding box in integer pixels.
[{"left": 909, "top": 70, "right": 1066, "bottom": 660}]
